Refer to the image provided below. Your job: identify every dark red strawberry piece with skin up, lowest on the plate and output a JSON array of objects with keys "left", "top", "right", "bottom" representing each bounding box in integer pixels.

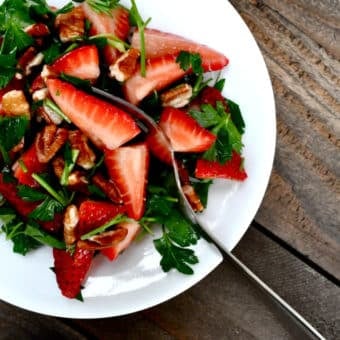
[{"left": 53, "top": 248, "right": 94, "bottom": 299}]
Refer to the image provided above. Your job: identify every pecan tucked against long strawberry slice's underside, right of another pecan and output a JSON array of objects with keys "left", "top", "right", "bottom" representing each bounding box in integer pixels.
[{"left": 68, "top": 130, "right": 96, "bottom": 170}]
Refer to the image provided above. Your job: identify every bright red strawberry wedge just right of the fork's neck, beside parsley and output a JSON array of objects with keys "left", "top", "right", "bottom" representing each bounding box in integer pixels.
[{"left": 159, "top": 107, "right": 216, "bottom": 152}]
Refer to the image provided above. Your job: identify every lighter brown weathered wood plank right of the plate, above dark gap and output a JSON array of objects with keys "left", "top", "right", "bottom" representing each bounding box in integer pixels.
[{"left": 231, "top": 0, "right": 340, "bottom": 279}]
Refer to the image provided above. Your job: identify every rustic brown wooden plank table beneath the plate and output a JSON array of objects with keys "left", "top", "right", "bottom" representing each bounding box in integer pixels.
[{"left": 0, "top": 0, "right": 340, "bottom": 339}]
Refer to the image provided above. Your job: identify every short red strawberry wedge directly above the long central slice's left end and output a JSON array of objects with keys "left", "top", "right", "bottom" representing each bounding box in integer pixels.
[{"left": 52, "top": 45, "right": 100, "bottom": 81}]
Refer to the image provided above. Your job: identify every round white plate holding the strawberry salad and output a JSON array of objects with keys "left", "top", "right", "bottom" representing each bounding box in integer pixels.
[{"left": 0, "top": 0, "right": 276, "bottom": 318}]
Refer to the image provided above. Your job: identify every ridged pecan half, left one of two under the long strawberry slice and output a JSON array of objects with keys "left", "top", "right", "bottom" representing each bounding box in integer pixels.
[{"left": 35, "top": 124, "right": 68, "bottom": 163}]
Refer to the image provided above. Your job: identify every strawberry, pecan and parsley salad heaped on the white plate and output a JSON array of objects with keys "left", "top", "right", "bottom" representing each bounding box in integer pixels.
[{"left": 0, "top": 0, "right": 247, "bottom": 298}]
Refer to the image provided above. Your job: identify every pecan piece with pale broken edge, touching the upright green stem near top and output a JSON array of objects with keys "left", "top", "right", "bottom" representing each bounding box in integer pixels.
[{"left": 110, "top": 48, "right": 140, "bottom": 82}]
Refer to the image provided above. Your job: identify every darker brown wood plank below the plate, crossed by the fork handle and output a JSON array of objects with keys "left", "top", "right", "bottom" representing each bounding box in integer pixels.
[{"left": 64, "top": 228, "right": 340, "bottom": 340}]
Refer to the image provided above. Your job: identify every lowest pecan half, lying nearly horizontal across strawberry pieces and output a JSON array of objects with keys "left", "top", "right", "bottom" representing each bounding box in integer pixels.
[{"left": 77, "top": 227, "right": 128, "bottom": 250}]
